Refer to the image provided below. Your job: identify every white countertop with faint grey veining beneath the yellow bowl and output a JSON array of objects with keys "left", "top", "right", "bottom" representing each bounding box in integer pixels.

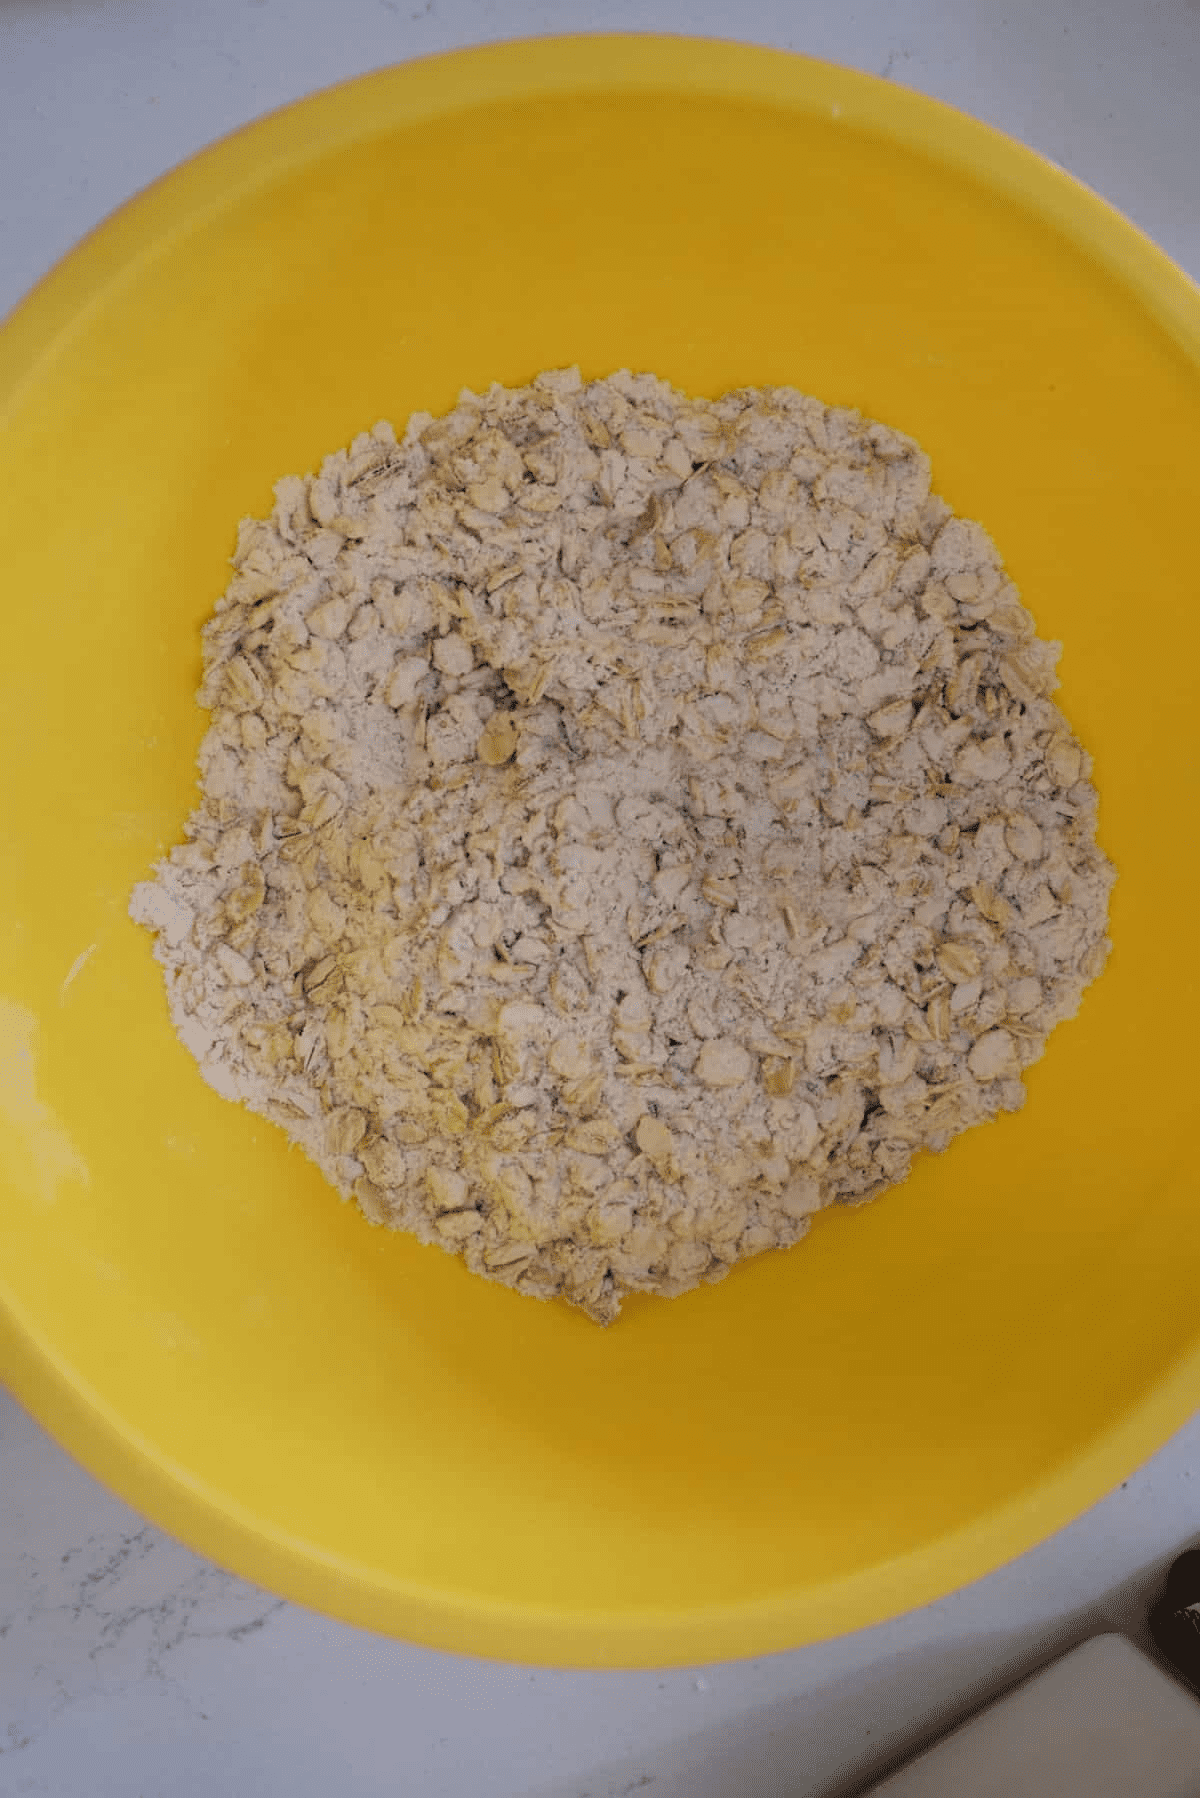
[{"left": 0, "top": 0, "right": 1200, "bottom": 1798}]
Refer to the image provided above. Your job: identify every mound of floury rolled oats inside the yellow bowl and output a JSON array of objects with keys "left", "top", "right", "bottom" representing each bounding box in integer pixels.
[{"left": 131, "top": 370, "right": 1114, "bottom": 1322}]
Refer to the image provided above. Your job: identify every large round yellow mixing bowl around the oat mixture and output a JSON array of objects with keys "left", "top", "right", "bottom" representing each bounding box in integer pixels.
[{"left": 0, "top": 38, "right": 1200, "bottom": 1665}]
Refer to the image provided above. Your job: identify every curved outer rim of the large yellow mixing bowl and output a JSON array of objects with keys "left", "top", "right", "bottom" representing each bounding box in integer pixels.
[{"left": 0, "top": 36, "right": 1200, "bottom": 1667}]
